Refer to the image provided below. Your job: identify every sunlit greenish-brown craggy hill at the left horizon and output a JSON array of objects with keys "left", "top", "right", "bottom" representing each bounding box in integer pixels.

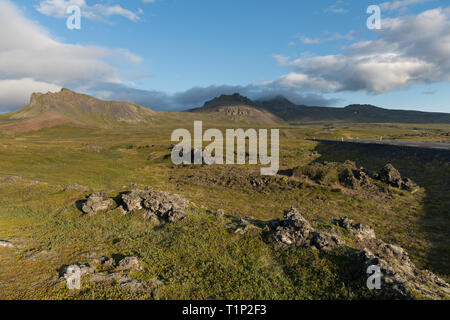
[{"left": 0, "top": 89, "right": 156, "bottom": 132}]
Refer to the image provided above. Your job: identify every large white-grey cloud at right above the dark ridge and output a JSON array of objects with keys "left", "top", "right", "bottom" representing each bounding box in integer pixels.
[{"left": 276, "top": 8, "right": 450, "bottom": 93}]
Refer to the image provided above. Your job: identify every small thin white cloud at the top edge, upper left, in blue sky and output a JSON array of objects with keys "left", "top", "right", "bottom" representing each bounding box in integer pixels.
[{"left": 36, "top": 0, "right": 142, "bottom": 21}]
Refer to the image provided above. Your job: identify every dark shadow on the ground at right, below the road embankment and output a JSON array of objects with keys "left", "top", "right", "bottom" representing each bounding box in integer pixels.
[{"left": 315, "top": 141, "right": 450, "bottom": 278}]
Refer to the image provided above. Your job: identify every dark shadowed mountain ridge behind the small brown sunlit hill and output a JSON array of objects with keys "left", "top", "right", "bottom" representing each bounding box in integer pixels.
[{"left": 189, "top": 93, "right": 450, "bottom": 123}]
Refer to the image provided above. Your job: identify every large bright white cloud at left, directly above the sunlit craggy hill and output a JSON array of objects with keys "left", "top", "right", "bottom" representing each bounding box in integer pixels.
[{"left": 0, "top": 0, "right": 141, "bottom": 109}]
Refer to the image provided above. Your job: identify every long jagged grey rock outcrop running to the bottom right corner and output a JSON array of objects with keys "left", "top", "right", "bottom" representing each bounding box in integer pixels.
[{"left": 274, "top": 208, "right": 450, "bottom": 299}]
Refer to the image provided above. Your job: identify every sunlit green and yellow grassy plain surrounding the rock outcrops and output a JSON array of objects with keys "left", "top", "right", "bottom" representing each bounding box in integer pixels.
[{"left": 0, "top": 113, "right": 450, "bottom": 299}]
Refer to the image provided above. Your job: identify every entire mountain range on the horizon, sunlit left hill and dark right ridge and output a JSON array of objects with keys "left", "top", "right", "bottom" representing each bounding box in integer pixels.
[{"left": 0, "top": 89, "right": 450, "bottom": 132}]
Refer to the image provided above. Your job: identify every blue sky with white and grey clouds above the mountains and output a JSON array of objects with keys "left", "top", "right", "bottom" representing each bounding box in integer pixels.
[{"left": 0, "top": 0, "right": 450, "bottom": 112}]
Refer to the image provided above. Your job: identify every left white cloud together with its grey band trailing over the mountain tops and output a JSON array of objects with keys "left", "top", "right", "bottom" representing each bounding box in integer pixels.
[{"left": 0, "top": 0, "right": 336, "bottom": 111}]
